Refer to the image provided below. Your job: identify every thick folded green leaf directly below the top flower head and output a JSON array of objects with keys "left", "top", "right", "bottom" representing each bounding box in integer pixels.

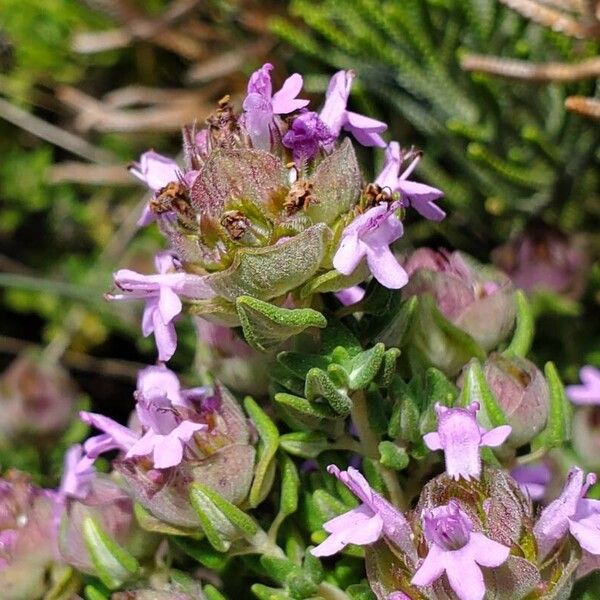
[{"left": 236, "top": 296, "right": 327, "bottom": 351}]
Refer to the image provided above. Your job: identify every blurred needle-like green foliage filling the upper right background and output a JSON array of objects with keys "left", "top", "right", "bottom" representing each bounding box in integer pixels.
[{"left": 273, "top": 0, "right": 600, "bottom": 251}]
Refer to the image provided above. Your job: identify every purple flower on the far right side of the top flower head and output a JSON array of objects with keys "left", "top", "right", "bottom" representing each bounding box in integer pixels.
[{"left": 375, "top": 142, "right": 446, "bottom": 221}]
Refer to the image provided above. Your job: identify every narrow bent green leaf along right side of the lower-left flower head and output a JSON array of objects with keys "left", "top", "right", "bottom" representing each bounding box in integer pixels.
[{"left": 244, "top": 396, "right": 279, "bottom": 508}]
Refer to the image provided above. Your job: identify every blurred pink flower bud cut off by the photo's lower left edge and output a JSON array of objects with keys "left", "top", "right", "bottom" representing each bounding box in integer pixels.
[{"left": 0, "top": 471, "right": 58, "bottom": 600}]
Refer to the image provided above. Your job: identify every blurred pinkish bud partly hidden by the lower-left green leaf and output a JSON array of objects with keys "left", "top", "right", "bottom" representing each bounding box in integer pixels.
[{"left": 58, "top": 474, "right": 155, "bottom": 575}]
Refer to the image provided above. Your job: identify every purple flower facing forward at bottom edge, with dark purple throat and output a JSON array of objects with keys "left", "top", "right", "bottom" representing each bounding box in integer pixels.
[{"left": 411, "top": 500, "right": 510, "bottom": 600}]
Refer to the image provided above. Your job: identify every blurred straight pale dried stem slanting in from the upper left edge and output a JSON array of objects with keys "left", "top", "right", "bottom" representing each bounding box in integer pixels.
[{"left": 0, "top": 98, "right": 116, "bottom": 164}]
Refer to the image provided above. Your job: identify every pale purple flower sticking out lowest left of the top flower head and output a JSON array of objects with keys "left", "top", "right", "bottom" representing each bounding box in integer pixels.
[{"left": 107, "top": 252, "right": 214, "bottom": 361}]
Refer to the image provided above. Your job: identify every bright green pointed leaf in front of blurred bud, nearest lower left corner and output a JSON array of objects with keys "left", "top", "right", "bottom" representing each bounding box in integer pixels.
[{"left": 82, "top": 517, "right": 139, "bottom": 590}]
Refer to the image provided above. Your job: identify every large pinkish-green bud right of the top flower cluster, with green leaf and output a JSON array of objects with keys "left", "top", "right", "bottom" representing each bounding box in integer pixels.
[{"left": 403, "top": 248, "right": 516, "bottom": 375}]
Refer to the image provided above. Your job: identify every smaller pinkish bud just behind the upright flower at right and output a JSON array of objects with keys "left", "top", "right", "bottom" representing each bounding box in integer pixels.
[{"left": 474, "top": 352, "right": 550, "bottom": 448}]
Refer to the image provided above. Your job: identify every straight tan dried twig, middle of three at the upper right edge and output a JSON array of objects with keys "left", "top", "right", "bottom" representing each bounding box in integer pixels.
[{"left": 460, "top": 54, "right": 600, "bottom": 82}]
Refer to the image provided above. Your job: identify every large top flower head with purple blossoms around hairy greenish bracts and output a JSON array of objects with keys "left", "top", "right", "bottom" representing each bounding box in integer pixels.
[{"left": 115, "top": 63, "right": 445, "bottom": 361}]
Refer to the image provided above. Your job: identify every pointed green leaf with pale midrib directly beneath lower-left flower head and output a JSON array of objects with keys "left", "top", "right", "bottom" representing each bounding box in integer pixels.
[{"left": 189, "top": 483, "right": 258, "bottom": 552}]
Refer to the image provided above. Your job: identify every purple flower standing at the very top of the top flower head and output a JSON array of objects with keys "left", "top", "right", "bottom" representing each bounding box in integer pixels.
[{"left": 243, "top": 63, "right": 309, "bottom": 150}]
